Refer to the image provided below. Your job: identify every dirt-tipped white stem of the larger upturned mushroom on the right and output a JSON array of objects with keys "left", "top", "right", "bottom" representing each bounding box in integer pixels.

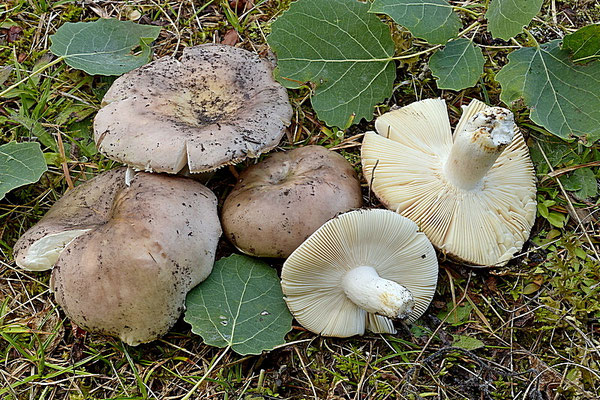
[{"left": 444, "top": 107, "right": 516, "bottom": 190}]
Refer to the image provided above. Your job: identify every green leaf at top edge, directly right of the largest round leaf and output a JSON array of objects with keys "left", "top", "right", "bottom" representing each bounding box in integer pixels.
[{"left": 370, "top": 0, "right": 461, "bottom": 44}]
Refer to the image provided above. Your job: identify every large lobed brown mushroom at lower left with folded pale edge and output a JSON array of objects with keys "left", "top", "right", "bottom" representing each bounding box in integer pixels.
[{"left": 15, "top": 168, "right": 221, "bottom": 345}]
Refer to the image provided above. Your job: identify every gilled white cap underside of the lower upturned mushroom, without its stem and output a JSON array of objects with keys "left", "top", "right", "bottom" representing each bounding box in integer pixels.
[{"left": 281, "top": 209, "right": 438, "bottom": 337}]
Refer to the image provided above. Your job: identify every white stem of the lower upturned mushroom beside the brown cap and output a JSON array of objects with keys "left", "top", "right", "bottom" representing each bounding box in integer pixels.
[{"left": 342, "top": 266, "right": 415, "bottom": 318}]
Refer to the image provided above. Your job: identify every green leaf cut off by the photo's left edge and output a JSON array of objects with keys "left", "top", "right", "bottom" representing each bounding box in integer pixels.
[{"left": 0, "top": 142, "right": 47, "bottom": 199}]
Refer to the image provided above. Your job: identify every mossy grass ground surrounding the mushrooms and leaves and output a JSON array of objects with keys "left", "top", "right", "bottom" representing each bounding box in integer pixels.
[{"left": 0, "top": 0, "right": 600, "bottom": 400}]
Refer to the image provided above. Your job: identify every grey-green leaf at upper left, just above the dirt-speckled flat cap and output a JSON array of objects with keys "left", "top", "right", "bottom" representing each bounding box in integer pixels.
[{"left": 50, "top": 18, "right": 160, "bottom": 75}]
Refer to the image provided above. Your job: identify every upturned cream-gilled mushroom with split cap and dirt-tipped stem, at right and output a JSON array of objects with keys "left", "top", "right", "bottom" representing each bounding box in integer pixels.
[{"left": 361, "top": 99, "right": 536, "bottom": 266}]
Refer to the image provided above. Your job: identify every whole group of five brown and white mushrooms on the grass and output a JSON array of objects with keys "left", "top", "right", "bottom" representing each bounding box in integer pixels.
[{"left": 14, "top": 41, "right": 536, "bottom": 345}]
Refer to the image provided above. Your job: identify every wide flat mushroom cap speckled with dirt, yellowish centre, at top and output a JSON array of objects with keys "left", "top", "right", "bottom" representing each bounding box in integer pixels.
[{"left": 94, "top": 44, "right": 292, "bottom": 173}]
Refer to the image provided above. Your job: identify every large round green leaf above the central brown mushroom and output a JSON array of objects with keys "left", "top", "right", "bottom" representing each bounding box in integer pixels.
[{"left": 267, "top": 0, "right": 396, "bottom": 128}]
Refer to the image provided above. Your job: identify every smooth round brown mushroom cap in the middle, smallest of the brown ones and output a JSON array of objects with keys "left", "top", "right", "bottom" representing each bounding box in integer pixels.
[{"left": 221, "top": 146, "right": 362, "bottom": 257}]
